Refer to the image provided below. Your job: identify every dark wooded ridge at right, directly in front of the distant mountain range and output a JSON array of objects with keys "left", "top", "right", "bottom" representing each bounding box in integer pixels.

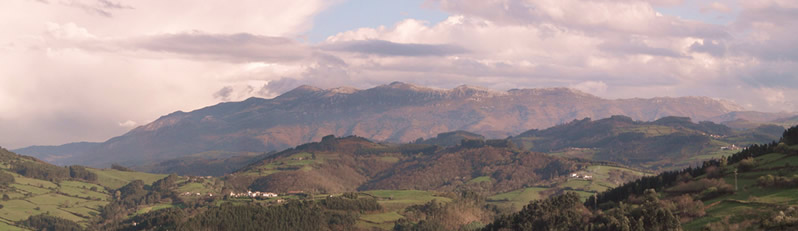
[{"left": 511, "top": 116, "right": 784, "bottom": 170}]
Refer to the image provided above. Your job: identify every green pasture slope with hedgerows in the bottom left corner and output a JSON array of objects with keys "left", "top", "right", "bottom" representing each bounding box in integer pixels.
[{"left": 0, "top": 148, "right": 165, "bottom": 230}]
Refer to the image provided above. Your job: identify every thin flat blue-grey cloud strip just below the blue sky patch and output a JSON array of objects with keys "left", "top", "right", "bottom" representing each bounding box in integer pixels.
[{"left": 321, "top": 40, "right": 467, "bottom": 56}]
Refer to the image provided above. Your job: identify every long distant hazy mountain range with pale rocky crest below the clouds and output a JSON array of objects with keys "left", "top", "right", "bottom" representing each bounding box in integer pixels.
[{"left": 15, "top": 82, "right": 782, "bottom": 169}]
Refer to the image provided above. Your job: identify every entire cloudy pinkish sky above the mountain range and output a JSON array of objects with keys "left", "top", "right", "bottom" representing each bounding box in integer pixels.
[{"left": 0, "top": 0, "right": 798, "bottom": 149}]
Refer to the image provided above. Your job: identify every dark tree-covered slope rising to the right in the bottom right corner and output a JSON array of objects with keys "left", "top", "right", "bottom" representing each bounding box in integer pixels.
[{"left": 483, "top": 127, "right": 798, "bottom": 231}]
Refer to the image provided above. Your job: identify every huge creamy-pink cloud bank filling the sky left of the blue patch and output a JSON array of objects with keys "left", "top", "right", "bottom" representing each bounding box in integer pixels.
[{"left": 0, "top": 0, "right": 333, "bottom": 148}]
